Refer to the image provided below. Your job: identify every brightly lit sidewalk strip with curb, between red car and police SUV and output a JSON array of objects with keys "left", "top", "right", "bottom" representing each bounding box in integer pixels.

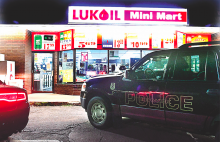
[{"left": 28, "top": 93, "right": 81, "bottom": 106}]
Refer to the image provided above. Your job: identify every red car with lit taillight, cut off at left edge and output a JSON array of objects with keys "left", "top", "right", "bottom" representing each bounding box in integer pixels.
[{"left": 0, "top": 82, "right": 30, "bottom": 140}]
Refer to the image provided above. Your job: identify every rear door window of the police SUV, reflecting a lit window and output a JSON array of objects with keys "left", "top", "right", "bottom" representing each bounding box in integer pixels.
[{"left": 173, "top": 51, "right": 207, "bottom": 80}]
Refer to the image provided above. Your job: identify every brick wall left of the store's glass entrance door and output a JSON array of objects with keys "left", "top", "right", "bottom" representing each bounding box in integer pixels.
[{"left": 0, "top": 27, "right": 30, "bottom": 92}]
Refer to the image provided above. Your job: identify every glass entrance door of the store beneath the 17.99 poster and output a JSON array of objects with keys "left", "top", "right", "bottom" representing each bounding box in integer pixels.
[{"left": 32, "top": 53, "right": 53, "bottom": 93}]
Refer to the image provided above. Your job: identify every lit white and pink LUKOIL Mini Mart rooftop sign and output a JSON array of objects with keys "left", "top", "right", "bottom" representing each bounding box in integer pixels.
[{"left": 68, "top": 6, "right": 187, "bottom": 25}]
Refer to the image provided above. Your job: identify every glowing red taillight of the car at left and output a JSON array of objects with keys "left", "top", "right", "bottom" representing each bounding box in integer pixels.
[{"left": 0, "top": 93, "right": 26, "bottom": 101}]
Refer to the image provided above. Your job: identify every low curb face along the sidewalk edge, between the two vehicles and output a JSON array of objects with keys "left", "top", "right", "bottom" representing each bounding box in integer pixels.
[{"left": 29, "top": 102, "right": 81, "bottom": 106}]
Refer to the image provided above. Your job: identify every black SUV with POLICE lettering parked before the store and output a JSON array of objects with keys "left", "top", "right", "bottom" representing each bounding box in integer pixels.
[{"left": 80, "top": 41, "right": 220, "bottom": 141}]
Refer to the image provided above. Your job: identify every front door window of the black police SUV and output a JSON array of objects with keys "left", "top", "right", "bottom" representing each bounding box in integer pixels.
[{"left": 135, "top": 53, "right": 170, "bottom": 80}]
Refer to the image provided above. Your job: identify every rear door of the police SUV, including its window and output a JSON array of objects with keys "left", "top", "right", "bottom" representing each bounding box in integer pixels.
[{"left": 165, "top": 48, "right": 219, "bottom": 130}]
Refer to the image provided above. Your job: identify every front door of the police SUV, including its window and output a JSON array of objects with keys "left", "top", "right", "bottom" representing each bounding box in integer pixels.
[{"left": 120, "top": 51, "right": 171, "bottom": 123}]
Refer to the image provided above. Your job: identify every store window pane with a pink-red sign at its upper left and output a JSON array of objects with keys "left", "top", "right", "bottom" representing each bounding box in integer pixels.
[{"left": 76, "top": 50, "right": 108, "bottom": 82}]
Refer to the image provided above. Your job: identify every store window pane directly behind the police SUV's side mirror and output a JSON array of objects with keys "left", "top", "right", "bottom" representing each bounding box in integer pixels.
[{"left": 109, "top": 50, "right": 141, "bottom": 74}]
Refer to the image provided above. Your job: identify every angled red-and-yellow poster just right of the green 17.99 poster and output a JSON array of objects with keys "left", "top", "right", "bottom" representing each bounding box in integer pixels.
[{"left": 60, "top": 30, "right": 73, "bottom": 51}]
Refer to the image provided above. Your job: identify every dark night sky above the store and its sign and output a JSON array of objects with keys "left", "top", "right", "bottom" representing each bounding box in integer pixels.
[{"left": 0, "top": 0, "right": 220, "bottom": 27}]
